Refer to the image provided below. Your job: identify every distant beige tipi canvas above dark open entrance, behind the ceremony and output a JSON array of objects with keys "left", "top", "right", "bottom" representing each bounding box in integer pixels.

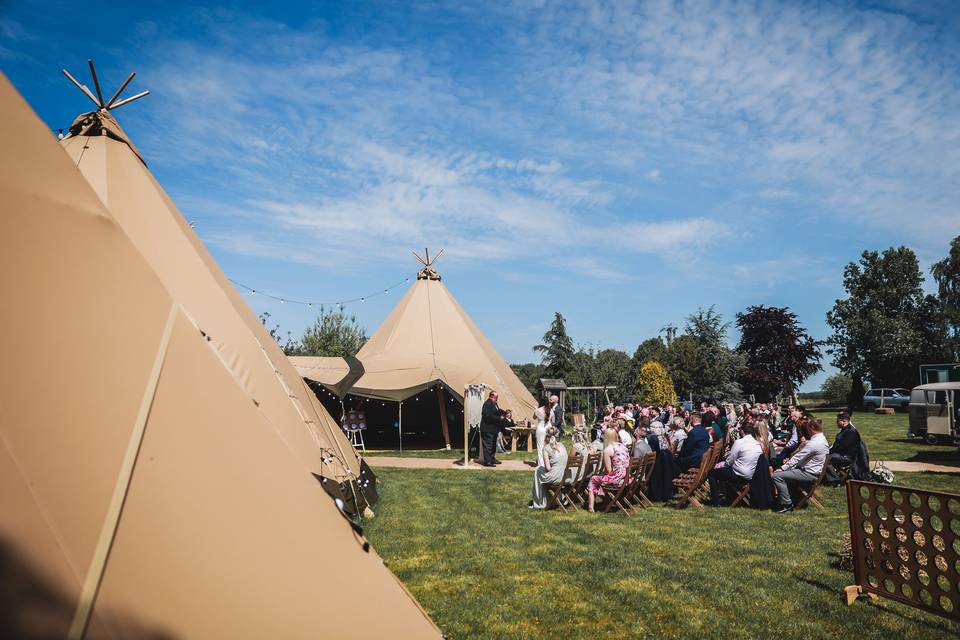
[{"left": 291, "top": 248, "right": 536, "bottom": 444}]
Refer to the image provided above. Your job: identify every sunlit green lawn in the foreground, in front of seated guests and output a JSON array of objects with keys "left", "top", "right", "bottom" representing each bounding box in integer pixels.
[{"left": 364, "top": 464, "right": 960, "bottom": 640}]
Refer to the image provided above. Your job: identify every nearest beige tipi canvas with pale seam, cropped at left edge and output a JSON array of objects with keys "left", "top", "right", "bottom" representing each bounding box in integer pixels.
[{"left": 0, "top": 74, "right": 439, "bottom": 638}]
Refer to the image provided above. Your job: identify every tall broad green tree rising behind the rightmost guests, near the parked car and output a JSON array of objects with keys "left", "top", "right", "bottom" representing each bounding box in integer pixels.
[{"left": 827, "top": 247, "right": 949, "bottom": 408}]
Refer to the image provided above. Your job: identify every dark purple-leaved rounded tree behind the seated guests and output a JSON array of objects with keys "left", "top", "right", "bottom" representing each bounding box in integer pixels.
[{"left": 737, "top": 305, "right": 822, "bottom": 402}]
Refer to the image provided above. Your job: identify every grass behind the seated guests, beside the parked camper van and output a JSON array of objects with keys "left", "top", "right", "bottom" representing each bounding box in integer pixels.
[{"left": 814, "top": 411, "right": 960, "bottom": 465}]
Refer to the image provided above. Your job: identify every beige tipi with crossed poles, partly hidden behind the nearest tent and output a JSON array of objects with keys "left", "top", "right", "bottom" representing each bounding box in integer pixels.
[{"left": 55, "top": 65, "right": 373, "bottom": 511}]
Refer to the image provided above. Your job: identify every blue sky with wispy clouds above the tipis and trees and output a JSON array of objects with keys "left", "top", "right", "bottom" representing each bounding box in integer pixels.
[{"left": 0, "top": 1, "right": 960, "bottom": 389}]
